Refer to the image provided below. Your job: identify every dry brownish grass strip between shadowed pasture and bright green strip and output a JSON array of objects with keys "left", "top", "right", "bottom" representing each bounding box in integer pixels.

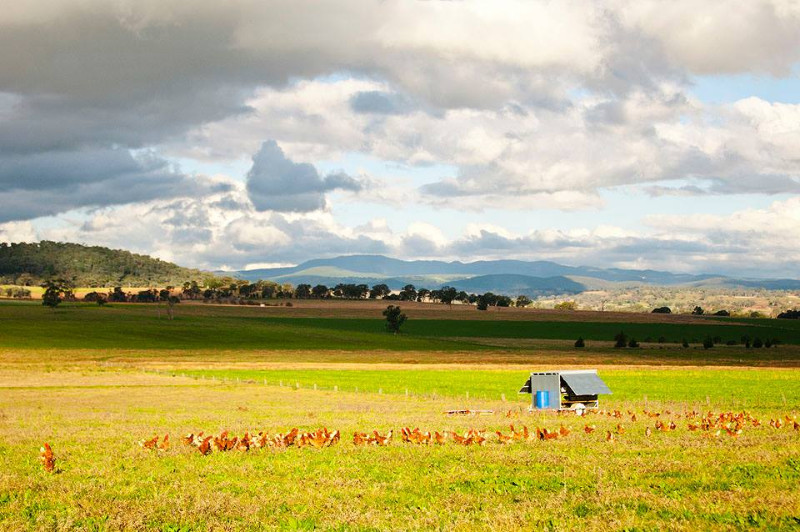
[{"left": 6, "top": 338, "right": 800, "bottom": 370}]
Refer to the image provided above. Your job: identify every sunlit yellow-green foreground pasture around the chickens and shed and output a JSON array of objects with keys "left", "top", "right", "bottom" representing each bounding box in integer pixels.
[{"left": 0, "top": 368, "right": 800, "bottom": 530}]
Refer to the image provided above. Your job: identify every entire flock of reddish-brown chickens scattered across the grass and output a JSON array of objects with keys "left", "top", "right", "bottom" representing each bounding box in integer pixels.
[{"left": 39, "top": 410, "right": 800, "bottom": 473}]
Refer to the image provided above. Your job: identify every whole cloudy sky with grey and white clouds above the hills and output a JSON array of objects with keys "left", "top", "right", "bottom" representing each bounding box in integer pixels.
[{"left": 0, "top": 0, "right": 800, "bottom": 277}]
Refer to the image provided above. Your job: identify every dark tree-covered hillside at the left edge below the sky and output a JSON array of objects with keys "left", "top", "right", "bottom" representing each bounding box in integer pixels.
[{"left": 0, "top": 241, "right": 212, "bottom": 287}]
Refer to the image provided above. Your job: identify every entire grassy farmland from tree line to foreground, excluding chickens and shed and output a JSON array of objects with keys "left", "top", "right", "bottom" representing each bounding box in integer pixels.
[{"left": 0, "top": 304, "right": 800, "bottom": 530}]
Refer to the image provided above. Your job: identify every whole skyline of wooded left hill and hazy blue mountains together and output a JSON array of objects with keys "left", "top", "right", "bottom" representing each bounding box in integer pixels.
[{"left": 0, "top": 241, "right": 800, "bottom": 297}]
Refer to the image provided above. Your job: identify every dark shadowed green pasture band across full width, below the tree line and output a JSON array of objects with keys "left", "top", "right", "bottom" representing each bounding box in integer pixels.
[{"left": 0, "top": 302, "right": 800, "bottom": 351}]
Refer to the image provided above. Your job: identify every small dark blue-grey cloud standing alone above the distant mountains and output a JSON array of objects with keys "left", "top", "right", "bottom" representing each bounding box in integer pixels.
[{"left": 247, "top": 140, "right": 362, "bottom": 212}]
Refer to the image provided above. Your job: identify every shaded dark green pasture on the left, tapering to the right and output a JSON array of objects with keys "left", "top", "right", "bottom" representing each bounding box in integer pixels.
[{"left": 0, "top": 303, "right": 476, "bottom": 351}]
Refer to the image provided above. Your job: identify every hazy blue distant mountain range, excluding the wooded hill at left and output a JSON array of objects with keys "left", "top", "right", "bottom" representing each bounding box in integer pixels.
[{"left": 235, "top": 255, "right": 800, "bottom": 296}]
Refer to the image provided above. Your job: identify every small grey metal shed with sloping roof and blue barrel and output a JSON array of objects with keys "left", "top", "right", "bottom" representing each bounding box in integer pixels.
[{"left": 519, "top": 369, "right": 611, "bottom": 410}]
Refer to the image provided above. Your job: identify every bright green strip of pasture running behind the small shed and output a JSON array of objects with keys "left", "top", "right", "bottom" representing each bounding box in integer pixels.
[{"left": 178, "top": 368, "right": 800, "bottom": 409}]
